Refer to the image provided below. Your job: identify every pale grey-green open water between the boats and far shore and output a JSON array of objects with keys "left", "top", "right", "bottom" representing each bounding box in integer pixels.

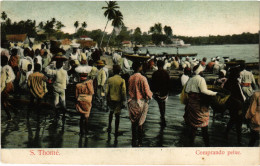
[{"left": 126, "top": 44, "right": 259, "bottom": 62}]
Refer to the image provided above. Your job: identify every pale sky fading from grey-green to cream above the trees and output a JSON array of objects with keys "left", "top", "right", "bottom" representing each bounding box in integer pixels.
[{"left": 1, "top": 1, "right": 260, "bottom": 36}]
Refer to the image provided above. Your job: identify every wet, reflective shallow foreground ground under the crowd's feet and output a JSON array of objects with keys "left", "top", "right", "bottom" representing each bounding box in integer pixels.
[{"left": 1, "top": 92, "right": 256, "bottom": 148}]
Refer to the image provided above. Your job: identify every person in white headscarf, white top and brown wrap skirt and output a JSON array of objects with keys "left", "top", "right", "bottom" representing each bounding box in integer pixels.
[{"left": 184, "top": 65, "right": 221, "bottom": 146}]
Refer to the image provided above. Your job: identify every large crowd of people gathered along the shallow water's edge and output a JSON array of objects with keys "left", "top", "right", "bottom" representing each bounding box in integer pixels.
[{"left": 1, "top": 42, "right": 260, "bottom": 146}]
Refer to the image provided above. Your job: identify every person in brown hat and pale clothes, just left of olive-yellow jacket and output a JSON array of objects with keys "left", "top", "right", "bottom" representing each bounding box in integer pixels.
[{"left": 97, "top": 60, "right": 107, "bottom": 109}]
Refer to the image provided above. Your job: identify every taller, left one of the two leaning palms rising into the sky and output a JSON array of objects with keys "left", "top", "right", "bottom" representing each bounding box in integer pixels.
[{"left": 100, "top": 1, "right": 119, "bottom": 47}]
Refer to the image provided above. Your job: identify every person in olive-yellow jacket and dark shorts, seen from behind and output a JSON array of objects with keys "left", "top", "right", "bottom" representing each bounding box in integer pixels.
[{"left": 106, "top": 65, "right": 126, "bottom": 134}]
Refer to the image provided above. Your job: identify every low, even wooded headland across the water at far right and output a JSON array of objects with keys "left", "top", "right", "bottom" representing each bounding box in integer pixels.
[{"left": 178, "top": 33, "right": 259, "bottom": 45}]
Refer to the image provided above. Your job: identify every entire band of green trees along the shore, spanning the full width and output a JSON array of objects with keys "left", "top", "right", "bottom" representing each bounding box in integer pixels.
[{"left": 1, "top": 12, "right": 259, "bottom": 46}]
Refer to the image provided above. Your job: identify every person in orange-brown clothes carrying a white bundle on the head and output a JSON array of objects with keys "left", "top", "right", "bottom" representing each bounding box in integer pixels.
[{"left": 75, "top": 66, "right": 94, "bottom": 135}]
